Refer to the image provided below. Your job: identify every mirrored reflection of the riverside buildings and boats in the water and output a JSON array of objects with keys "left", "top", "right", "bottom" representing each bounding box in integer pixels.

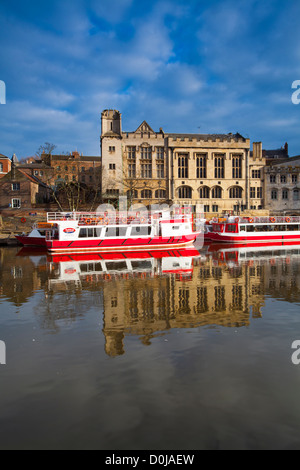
[{"left": 0, "top": 245, "right": 300, "bottom": 356}]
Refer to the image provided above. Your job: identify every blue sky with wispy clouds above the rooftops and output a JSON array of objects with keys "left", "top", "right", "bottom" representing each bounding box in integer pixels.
[{"left": 0, "top": 0, "right": 300, "bottom": 159}]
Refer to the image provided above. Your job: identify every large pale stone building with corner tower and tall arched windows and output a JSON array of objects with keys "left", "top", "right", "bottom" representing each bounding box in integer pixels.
[{"left": 101, "top": 110, "right": 265, "bottom": 215}]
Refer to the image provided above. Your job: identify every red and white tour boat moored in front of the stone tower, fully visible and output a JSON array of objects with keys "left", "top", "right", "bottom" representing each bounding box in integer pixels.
[{"left": 40, "top": 210, "right": 200, "bottom": 253}]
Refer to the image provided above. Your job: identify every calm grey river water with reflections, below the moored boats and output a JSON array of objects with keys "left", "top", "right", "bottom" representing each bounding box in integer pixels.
[{"left": 0, "top": 245, "right": 300, "bottom": 450}]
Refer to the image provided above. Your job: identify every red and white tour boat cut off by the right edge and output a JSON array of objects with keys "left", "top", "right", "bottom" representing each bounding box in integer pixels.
[{"left": 210, "top": 217, "right": 300, "bottom": 246}]
